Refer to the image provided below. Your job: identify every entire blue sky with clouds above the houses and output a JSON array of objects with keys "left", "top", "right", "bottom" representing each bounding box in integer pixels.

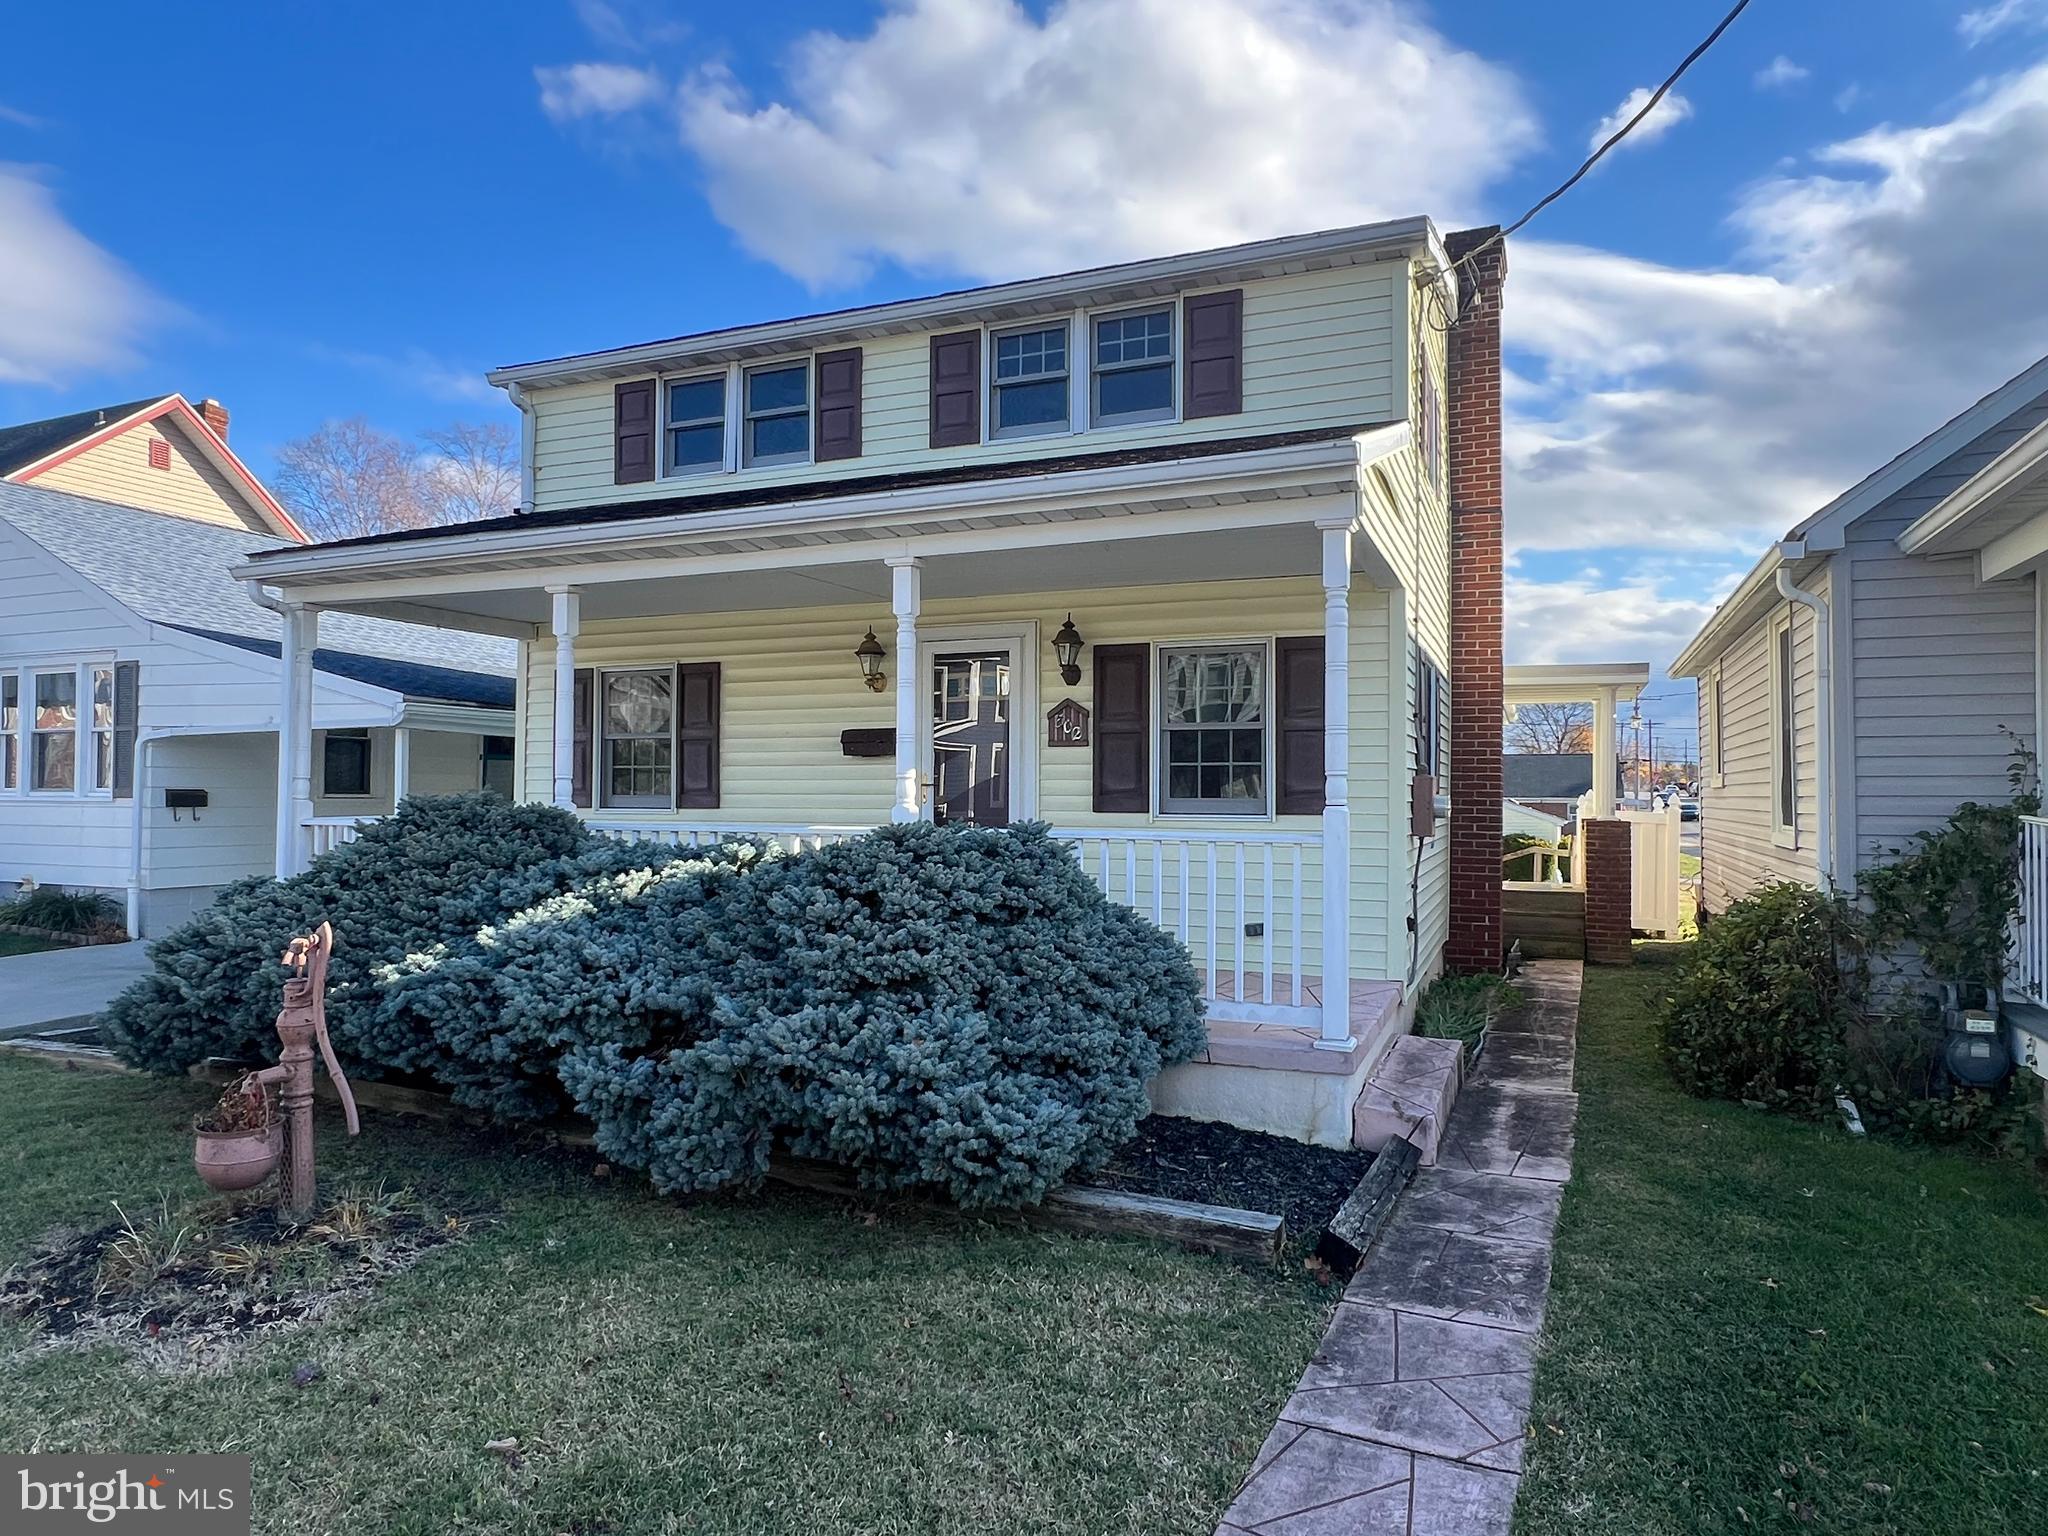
[{"left": 0, "top": 0, "right": 2048, "bottom": 765}]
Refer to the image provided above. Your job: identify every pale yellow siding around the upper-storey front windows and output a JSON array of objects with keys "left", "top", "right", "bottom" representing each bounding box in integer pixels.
[{"left": 532, "top": 262, "right": 1407, "bottom": 510}]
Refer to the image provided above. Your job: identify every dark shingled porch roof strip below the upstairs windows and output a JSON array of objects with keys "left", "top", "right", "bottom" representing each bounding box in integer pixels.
[{"left": 254, "top": 422, "right": 1386, "bottom": 559}]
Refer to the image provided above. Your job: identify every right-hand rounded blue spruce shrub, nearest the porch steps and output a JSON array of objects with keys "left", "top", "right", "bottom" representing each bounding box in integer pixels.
[{"left": 552, "top": 825, "right": 1204, "bottom": 1206}]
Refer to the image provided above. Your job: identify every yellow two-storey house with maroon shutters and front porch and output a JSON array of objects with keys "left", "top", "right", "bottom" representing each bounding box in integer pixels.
[{"left": 240, "top": 219, "right": 1523, "bottom": 1143}]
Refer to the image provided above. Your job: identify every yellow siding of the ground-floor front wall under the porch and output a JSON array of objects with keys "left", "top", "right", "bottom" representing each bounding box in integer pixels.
[{"left": 520, "top": 578, "right": 1407, "bottom": 977}]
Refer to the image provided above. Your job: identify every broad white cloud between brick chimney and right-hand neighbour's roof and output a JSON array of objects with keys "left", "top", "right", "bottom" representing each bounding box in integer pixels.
[{"left": 1507, "top": 66, "right": 2048, "bottom": 553}]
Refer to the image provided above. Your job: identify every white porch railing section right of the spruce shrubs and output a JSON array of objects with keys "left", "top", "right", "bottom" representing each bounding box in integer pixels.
[{"left": 1053, "top": 827, "right": 1323, "bottom": 1026}]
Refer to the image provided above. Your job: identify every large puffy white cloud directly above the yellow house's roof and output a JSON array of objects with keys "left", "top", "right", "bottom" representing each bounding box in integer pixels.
[{"left": 543, "top": 0, "right": 1534, "bottom": 287}]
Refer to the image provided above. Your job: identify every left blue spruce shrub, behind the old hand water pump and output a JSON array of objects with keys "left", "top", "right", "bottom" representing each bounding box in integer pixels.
[{"left": 102, "top": 795, "right": 610, "bottom": 1073}]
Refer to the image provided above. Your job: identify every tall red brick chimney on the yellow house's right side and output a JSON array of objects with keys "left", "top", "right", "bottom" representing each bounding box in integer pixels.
[{"left": 1444, "top": 225, "right": 1507, "bottom": 971}]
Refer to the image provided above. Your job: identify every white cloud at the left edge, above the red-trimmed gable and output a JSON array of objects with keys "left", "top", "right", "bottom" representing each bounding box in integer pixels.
[{"left": 0, "top": 162, "right": 170, "bottom": 385}]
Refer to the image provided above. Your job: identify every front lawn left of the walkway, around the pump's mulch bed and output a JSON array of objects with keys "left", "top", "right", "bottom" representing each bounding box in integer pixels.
[{"left": 0, "top": 1059, "right": 1335, "bottom": 1536}]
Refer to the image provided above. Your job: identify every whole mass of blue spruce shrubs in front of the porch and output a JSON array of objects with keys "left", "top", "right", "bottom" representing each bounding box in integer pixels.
[{"left": 109, "top": 797, "right": 1204, "bottom": 1204}]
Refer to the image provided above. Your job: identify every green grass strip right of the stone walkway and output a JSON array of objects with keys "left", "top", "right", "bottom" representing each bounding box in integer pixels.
[{"left": 1516, "top": 946, "right": 2048, "bottom": 1536}]
